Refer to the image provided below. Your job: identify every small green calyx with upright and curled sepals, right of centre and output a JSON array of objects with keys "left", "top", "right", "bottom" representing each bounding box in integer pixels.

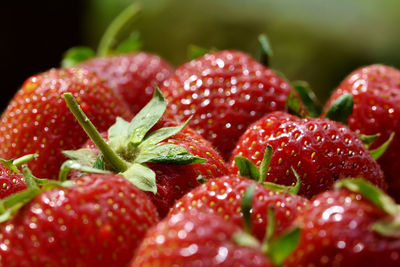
[{"left": 235, "top": 145, "right": 301, "bottom": 194}]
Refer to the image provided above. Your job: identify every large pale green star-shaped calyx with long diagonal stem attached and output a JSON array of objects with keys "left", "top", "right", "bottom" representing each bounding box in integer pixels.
[{"left": 60, "top": 87, "right": 206, "bottom": 193}]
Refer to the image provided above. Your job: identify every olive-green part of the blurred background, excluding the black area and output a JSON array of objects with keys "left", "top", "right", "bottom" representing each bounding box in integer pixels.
[{"left": 84, "top": 0, "right": 400, "bottom": 101}]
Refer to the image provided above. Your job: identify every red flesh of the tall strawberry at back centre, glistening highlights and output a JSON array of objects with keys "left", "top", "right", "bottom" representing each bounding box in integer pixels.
[{"left": 161, "top": 50, "right": 293, "bottom": 160}]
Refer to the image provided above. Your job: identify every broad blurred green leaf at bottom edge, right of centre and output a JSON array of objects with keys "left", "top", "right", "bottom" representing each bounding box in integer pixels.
[{"left": 267, "top": 227, "right": 300, "bottom": 266}]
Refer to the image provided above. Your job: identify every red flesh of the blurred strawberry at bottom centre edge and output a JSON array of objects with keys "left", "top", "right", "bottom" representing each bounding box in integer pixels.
[{"left": 131, "top": 210, "right": 273, "bottom": 267}]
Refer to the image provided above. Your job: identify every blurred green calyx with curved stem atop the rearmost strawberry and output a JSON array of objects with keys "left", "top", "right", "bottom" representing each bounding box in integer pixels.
[{"left": 61, "top": 3, "right": 142, "bottom": 68}]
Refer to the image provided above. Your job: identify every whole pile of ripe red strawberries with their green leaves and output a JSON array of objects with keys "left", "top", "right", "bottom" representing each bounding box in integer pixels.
[{"left": 0, "top": 7, "right": 400, "bottom": 267}]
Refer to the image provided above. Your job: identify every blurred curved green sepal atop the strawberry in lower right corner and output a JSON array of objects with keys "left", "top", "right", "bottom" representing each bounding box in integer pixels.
[{"left": 334, "top": 178, "right": 399, "bottom": 215}]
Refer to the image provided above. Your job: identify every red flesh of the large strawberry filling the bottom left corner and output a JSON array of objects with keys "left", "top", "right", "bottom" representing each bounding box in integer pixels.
[{"left": 0, "top": 174, "right": 158, "bottom": 267}]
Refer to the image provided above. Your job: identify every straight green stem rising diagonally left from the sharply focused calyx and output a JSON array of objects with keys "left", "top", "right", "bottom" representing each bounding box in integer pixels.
[{"left": 64, "top": 93, "right": 128, "bottom": 172}]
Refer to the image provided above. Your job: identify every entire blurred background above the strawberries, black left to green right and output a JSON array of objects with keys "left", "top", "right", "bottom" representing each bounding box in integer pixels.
[{"left": 0, "top": 0, "right": 400, "bottom": 110}]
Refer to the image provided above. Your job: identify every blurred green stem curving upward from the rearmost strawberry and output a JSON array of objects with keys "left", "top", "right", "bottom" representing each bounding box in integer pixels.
[{"left": 97, "top": 3, "right": 141, "bottom": 56}]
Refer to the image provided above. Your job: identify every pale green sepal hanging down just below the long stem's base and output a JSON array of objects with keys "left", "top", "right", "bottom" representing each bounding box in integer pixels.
[{"left": 120, "top": 163, "right": 157, "bottom": 194}]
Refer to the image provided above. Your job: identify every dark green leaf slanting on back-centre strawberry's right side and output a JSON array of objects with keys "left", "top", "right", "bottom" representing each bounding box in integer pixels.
[{"left": 292, "top": 81, "right": 322, "bottom": 117}]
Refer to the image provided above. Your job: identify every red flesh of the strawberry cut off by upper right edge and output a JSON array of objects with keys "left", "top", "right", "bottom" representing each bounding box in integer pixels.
[{"left": 325, "top": 65, "right": 400, "bottom": 202}]
